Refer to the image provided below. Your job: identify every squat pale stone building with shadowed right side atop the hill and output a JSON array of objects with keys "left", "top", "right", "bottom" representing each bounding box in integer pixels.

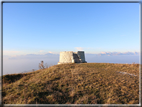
[{"left": 58, "top": 51, "right": 86, "bottom": 64}]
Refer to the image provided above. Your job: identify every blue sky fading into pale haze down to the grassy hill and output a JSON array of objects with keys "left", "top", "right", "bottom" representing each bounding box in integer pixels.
[{"left": 3, "top": 3, "right": 140, "bottom": 74}]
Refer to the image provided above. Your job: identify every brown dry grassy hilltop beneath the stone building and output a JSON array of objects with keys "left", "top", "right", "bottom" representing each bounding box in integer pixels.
[{"left": 2, "top": 63, "right": 139, "bottom": 104}]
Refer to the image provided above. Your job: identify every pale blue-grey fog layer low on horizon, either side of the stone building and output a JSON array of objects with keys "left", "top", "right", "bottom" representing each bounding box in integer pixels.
[{"left": 3, "top": 53, "right": 139, "bottom": 75}]
